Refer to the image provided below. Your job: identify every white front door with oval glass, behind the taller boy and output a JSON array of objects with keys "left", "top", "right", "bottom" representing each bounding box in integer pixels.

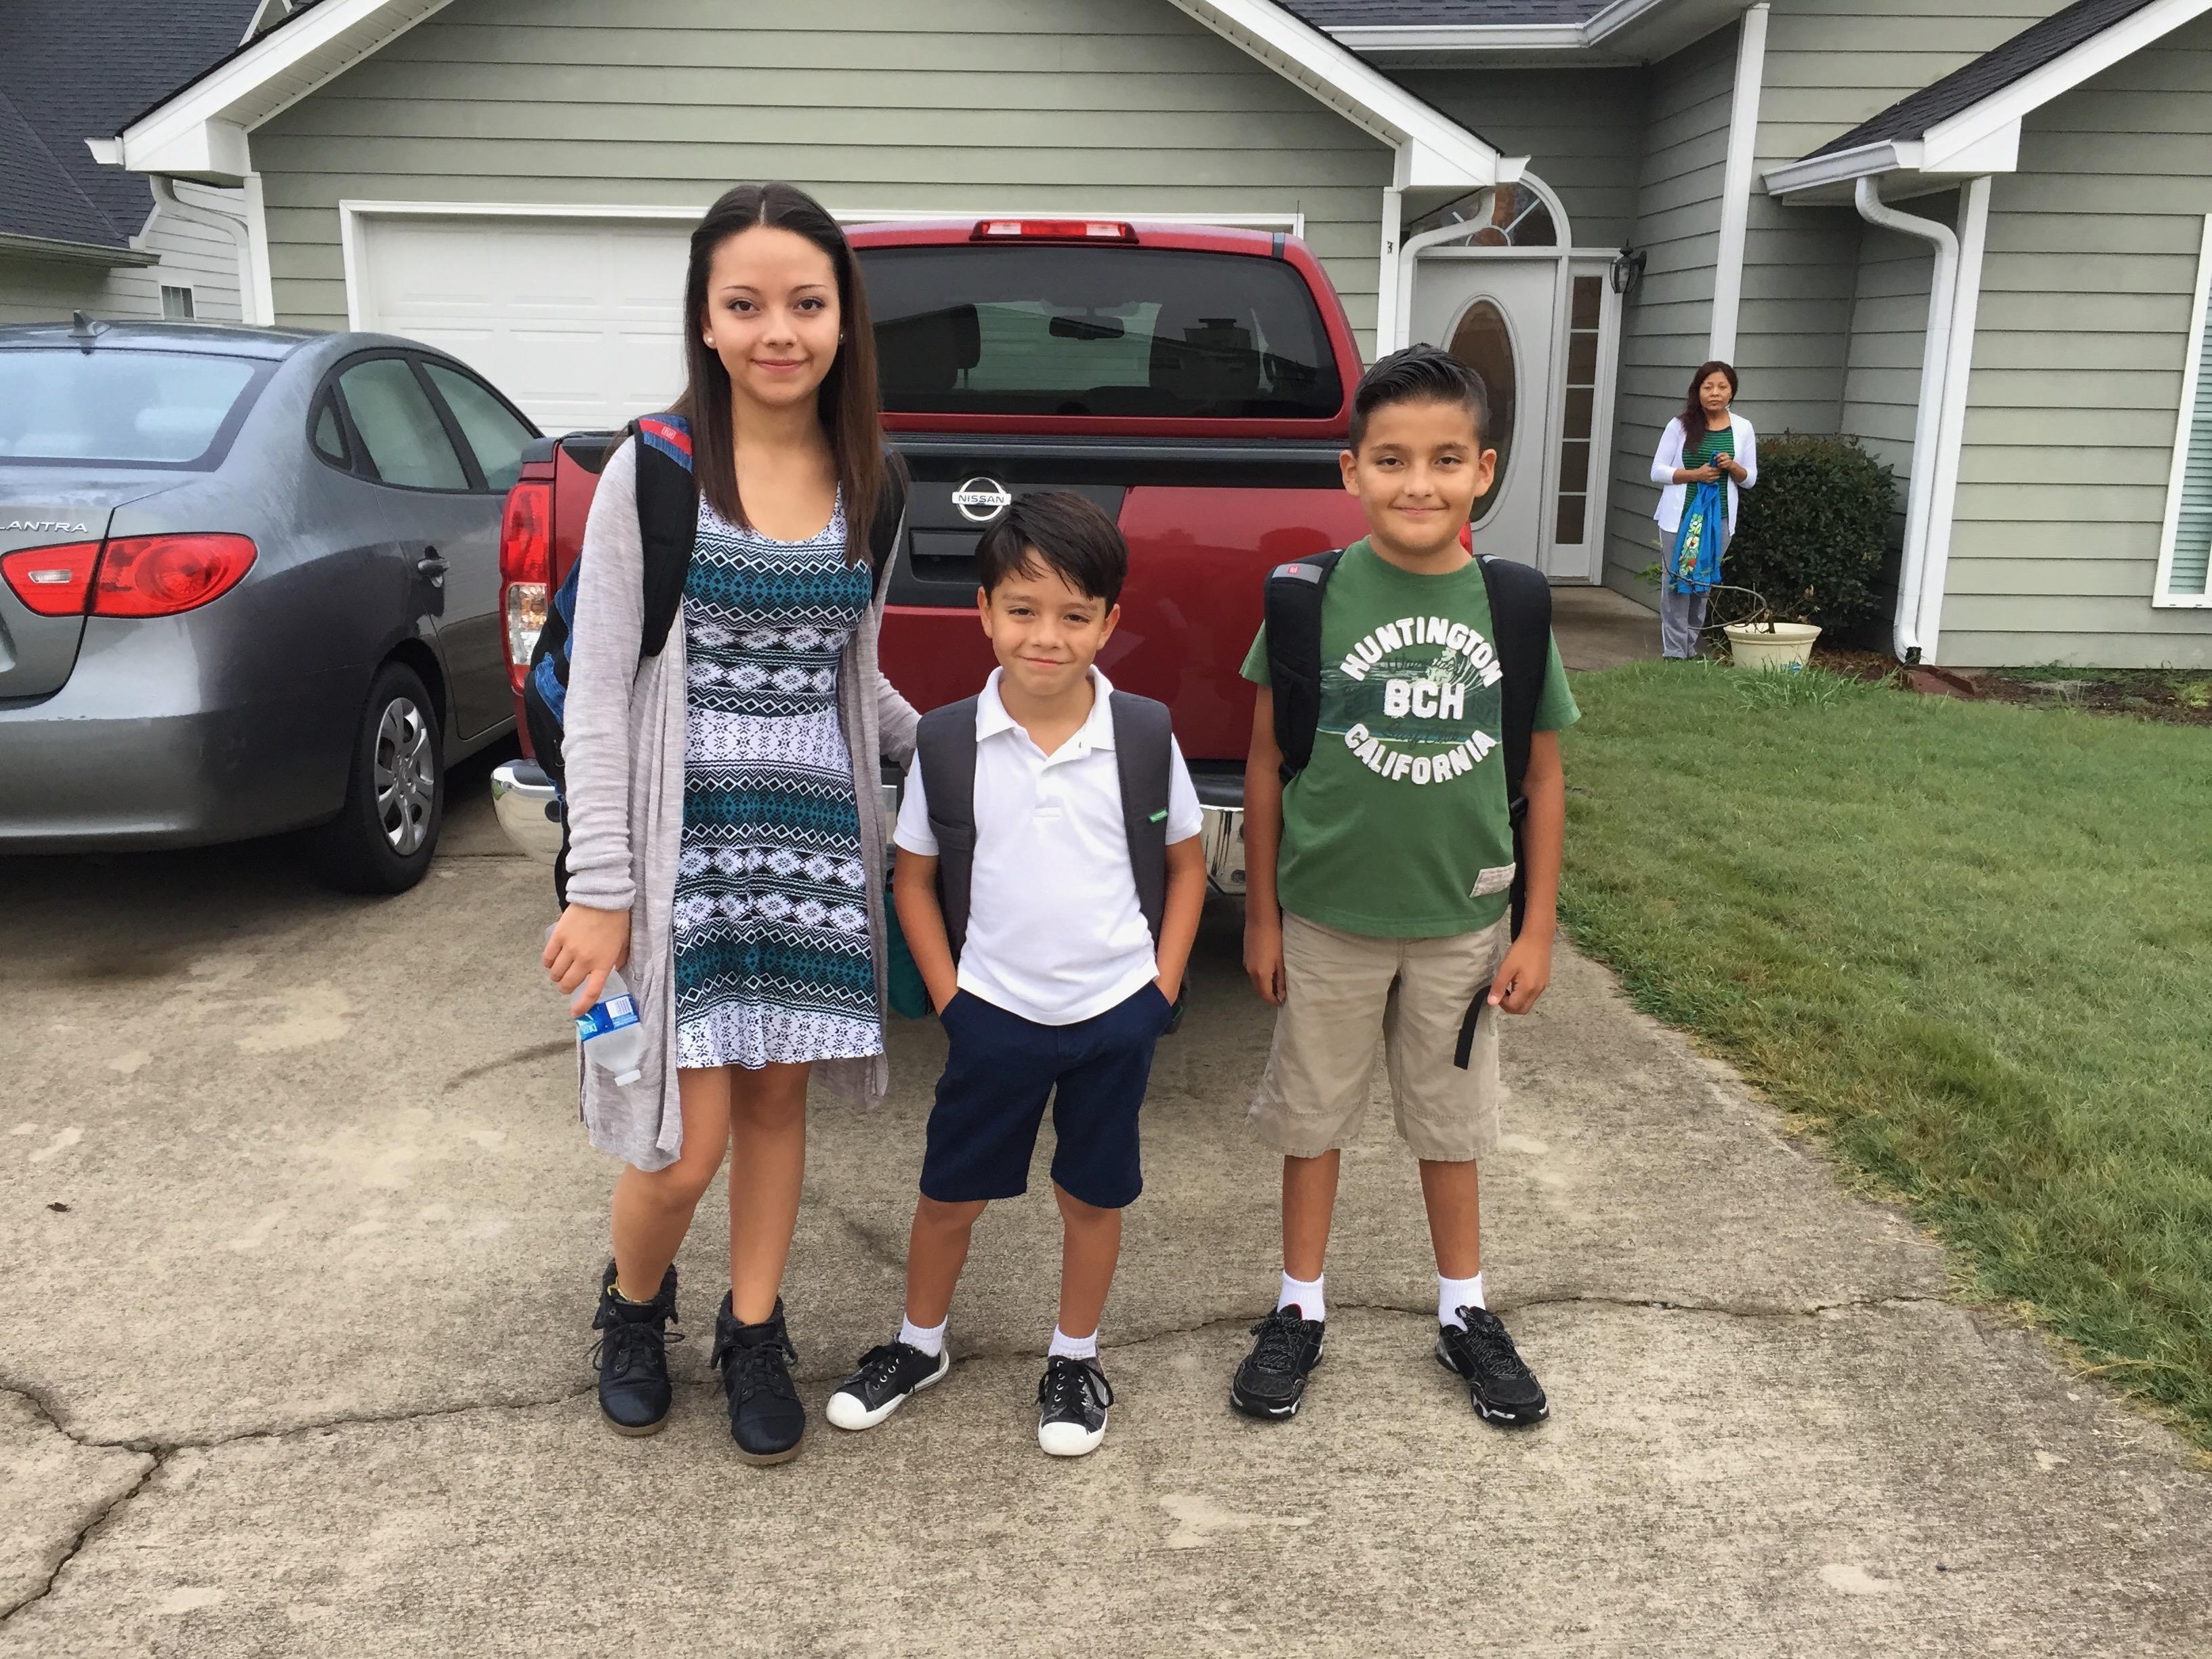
[{"left": 1411, "top": 248, "right": 1582, "bottom": 575}]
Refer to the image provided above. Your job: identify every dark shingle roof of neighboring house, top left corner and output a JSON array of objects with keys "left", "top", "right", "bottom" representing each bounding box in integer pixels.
[{"left": 0, "top": 0, "right": 257, "bottom": 248}]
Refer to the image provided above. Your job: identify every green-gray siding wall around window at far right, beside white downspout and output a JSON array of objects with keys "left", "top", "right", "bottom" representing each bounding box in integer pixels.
[{"left": 1938, "top": 20, "right": 2212, "bottom": 668}]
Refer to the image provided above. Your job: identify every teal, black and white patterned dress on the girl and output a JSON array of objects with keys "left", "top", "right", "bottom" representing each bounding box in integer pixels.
[{"left": 675, "top": 495, "right": 882, "bottom": 1069}]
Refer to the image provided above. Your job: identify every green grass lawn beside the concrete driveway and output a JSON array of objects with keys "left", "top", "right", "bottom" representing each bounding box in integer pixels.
[{"left": 1561, "top": 663, "right": 2212, "bottom": 1447}]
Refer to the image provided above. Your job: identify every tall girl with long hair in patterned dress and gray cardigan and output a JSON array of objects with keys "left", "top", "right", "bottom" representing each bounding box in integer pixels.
[{"left": 544, "top": 184, "right": 914, "bottom": 1462}]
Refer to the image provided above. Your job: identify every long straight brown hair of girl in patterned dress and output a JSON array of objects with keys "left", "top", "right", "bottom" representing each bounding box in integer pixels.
[{"left": 677, "top": 184, "right": 882, "bottom": 564}]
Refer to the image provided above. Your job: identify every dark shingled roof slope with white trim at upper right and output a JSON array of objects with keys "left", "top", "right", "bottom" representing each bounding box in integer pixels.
[{"left": 1765, "top": 0, "right": 2212, "bottom": 201}]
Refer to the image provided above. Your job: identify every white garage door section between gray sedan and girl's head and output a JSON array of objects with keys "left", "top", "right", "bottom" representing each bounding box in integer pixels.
[{"left": 354, "top": 215, "right": 690, "bottom": 434}]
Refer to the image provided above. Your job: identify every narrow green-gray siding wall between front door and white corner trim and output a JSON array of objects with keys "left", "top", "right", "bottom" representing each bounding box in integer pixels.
[{"left": 1601, "top": 26, "right": 1736, "bottom": 604}]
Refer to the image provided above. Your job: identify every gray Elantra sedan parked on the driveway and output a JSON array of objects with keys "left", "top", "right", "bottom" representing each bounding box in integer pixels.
[{"left": 0, "top": 327, "right": 537, "bottom": 891}]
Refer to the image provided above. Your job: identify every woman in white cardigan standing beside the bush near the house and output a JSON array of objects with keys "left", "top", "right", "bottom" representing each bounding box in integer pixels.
[{"left": 1652, "top": 363, "right": 1759, "bottom": 657}]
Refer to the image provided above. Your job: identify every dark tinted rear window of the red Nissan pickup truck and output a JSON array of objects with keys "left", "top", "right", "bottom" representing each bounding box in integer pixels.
[{"left": 861, "top": 243, "right": 1345, "bottom": 420}]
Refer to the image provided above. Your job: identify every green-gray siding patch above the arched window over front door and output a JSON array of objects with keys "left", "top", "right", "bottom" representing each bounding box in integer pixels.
[{"left": 1391, "top": 68, "right": 1645, "bottom": 248}]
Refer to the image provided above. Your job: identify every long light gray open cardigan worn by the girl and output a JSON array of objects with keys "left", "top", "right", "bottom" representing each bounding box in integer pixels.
[{"left": 562, "top": 441, "right": 916, "bottom": 1170}]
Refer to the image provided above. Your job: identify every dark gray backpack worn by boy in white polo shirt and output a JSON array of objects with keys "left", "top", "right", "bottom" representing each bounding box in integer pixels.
[{"left": 914, "top": 690, "right": 1188, "bottom": 1031}]
